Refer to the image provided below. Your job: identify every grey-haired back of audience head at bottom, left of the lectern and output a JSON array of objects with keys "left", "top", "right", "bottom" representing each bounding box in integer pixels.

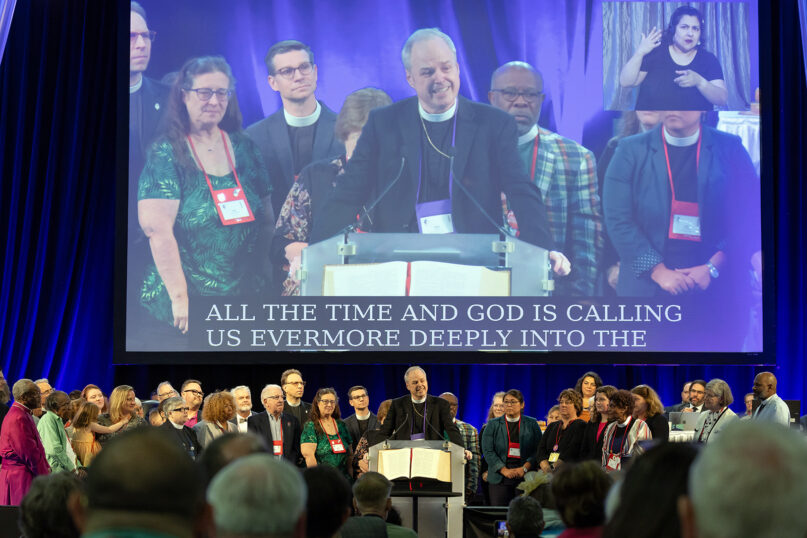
[{"left": 207, "top": 454, "right": 307, "bottom": 536}]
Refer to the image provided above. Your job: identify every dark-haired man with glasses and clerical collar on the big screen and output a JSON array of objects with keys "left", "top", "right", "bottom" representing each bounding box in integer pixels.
[{"left": 247, "top": 40, "right": 345, "bottom": 216}]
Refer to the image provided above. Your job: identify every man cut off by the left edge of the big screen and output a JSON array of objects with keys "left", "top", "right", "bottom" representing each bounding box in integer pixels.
[{"left": 127, "top": 2, "right": 169, "bottom": 319}]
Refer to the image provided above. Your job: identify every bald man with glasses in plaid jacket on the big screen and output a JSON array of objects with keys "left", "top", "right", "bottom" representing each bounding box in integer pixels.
[{"left": 488, "top": 62, "right": 604, "bottom": 297}]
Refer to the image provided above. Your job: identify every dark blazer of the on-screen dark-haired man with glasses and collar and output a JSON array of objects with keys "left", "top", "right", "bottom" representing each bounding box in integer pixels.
[{"left": 246, "top": 101, "right": 345, "bottom": 217}]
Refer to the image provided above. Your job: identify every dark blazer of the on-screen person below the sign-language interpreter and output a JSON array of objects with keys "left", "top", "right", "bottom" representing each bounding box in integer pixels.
[{"left": 603, "top": 125, "right": 761, "bottom": 297}]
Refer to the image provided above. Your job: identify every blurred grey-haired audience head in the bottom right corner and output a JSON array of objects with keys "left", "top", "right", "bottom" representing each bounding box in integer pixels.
[{"left": 689, "top": 420, "right": 807, "bottom": 538}]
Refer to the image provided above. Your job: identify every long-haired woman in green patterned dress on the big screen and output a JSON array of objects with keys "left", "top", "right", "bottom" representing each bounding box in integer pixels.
[{"left": 137, "top": 56, "right": 273, "bottom": 341}]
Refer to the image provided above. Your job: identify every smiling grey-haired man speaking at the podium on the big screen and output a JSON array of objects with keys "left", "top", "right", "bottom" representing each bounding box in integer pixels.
[{"left": 312, "top": 28, "right": 570, "bottom": 275}]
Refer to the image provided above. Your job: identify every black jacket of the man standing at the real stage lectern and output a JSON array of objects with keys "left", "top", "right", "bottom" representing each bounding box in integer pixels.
[{"left": 379, "top": 394, "right": 465, "bottom": 447}]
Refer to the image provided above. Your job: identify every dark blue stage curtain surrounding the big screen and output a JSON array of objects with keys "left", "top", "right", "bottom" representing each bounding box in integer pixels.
[{"left": 0, "top": 0, "right": 807, "bottom": 425}]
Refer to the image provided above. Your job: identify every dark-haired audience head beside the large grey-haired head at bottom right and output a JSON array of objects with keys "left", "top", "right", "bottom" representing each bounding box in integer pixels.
[{"left": 602, "top": 443, "right": 698, "bottom": 538}]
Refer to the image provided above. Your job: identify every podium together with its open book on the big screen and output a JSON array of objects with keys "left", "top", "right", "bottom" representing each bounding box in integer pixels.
[{"left": 298, "top": 233, "right": 554, "bottom": 297}]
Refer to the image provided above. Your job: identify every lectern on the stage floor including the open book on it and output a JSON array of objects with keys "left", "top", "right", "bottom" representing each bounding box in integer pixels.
[{"left": 370, "top": 441, "right": 465, "bottom": 538}]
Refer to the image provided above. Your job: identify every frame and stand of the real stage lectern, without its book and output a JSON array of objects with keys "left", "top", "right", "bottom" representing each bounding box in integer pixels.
[{"left": 369, "top": 440, "right": 465, "bottom": 538}]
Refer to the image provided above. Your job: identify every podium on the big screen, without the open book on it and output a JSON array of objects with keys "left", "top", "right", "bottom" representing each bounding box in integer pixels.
[{"left": 298, "top": 233, "right": 554, "bottom": 297}]
